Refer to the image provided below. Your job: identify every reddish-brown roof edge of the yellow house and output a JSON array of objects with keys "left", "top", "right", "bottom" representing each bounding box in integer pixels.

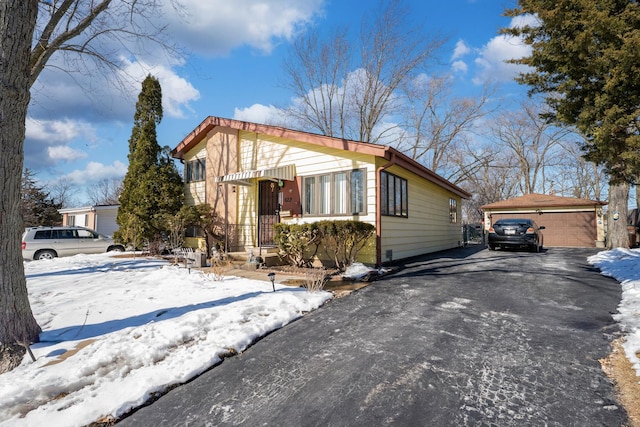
[{"left": 171, "top": 116, "right": 471, "bottom": 199}]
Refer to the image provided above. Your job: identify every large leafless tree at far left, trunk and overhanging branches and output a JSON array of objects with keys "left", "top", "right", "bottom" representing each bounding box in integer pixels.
[{"left": 0, "top": 0, "right": 180, "bottom": 372}]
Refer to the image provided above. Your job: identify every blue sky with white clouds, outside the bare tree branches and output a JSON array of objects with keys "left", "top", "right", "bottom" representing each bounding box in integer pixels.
[{"left": 25, "top": 0, "right": 526, "bottom": 205}]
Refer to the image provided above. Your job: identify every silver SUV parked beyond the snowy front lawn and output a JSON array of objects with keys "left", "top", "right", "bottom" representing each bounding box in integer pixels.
[{"left": 22, "top": 226, "right": 124, "bottom": 260}]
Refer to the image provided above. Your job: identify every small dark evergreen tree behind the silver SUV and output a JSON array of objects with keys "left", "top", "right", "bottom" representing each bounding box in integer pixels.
[{"left": 20, "top": 169, "right": 62, "bottom": 227}]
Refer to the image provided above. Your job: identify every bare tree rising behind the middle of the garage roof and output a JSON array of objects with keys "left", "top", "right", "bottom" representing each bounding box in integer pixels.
[{"left": 490, "top": 102, "right": 571, "bottom": 194}]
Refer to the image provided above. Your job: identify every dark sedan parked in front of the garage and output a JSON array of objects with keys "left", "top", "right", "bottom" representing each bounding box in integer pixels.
[{"left": 489, "top": 218, "right": 544, "bottom": 252}]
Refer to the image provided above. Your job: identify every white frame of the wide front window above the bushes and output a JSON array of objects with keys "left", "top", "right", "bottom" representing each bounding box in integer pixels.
[{"left": 301, "top": 168, "right": 367, "bottom": 217}]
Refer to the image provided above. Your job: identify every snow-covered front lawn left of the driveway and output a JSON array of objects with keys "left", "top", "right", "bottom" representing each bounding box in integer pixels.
[{"left": 0, "top": 254, "right": 331, "bottom": 427}]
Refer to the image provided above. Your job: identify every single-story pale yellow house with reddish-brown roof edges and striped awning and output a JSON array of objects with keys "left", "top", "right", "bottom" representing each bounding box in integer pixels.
[{"left": 172, "top": 117, "right": 470, "bottom": 265}]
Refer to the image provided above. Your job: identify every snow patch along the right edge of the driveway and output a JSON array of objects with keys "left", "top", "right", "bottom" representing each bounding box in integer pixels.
[{"left": 588, "top": 248, "right": 640, "bottom": 376}]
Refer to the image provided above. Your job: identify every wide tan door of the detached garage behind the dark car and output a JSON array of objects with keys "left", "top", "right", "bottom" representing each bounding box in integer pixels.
[{"left": 491, "top": 212, "right": 596, "bottom": 248}]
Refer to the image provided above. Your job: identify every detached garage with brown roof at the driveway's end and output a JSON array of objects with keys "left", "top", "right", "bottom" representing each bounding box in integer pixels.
[{"left": 481, "top": 194, "right": 606, "bottom": 248}]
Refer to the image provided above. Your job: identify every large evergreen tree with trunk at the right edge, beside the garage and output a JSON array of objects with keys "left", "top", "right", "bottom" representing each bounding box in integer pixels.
[{"left": 503, "top": 0, "right": 640, "bottom": 248}]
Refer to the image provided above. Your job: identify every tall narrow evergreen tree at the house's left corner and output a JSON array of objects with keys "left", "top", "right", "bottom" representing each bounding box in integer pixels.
[{"left": 115, "top": 75, "right": 183, "bottom": 244}]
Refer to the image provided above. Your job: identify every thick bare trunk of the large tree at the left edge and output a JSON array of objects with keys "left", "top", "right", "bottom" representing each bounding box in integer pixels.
[{"left": 0, "top": 0, "right": 41, "bottom": 370}]
